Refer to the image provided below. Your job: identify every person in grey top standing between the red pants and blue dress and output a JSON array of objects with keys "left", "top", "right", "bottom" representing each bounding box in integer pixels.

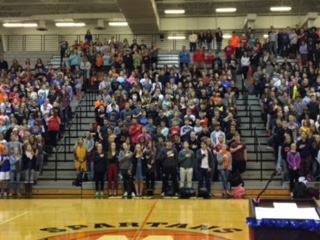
[{"left": 119, "top": 143, "right": 132, "bottom": 198}]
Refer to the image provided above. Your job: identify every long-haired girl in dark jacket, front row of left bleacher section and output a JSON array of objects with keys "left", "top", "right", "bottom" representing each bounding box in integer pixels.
[{"left": 22, "top": 143, "right": 37, "bottom": 198}]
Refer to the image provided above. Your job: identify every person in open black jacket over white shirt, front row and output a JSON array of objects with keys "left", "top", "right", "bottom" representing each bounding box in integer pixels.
[{"left": 196, "top": 142, "right": 216, "bottom": 196}]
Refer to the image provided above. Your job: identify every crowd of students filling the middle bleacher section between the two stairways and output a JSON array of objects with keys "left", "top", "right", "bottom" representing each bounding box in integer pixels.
[{"left": 67, "top": 31, "right": 247, "bottom": 197}]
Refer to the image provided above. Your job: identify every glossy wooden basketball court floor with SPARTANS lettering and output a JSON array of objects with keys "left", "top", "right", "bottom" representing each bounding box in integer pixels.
[{"left": 0, "top": 199, "right": 249, "bottom": 240}]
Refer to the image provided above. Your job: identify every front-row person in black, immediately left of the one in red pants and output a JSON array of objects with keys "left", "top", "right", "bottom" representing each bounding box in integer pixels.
[{"left": 93, "top": 143, "right": 108, "bottom": 198}]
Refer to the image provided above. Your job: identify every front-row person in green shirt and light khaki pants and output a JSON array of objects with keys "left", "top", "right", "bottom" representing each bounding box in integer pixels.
[{"left": 179, "top": 141, "right": 195, "bottom": 188}]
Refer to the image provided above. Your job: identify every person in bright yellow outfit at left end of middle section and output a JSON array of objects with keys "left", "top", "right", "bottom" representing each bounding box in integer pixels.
[{"left": 73, "top": 137, "right": 88, "bottom": 174}]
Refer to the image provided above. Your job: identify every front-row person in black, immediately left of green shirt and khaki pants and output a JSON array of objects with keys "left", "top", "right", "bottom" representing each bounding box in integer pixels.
[{"left": 158, "top": 139, "right": 178, "bottom": 197}]
